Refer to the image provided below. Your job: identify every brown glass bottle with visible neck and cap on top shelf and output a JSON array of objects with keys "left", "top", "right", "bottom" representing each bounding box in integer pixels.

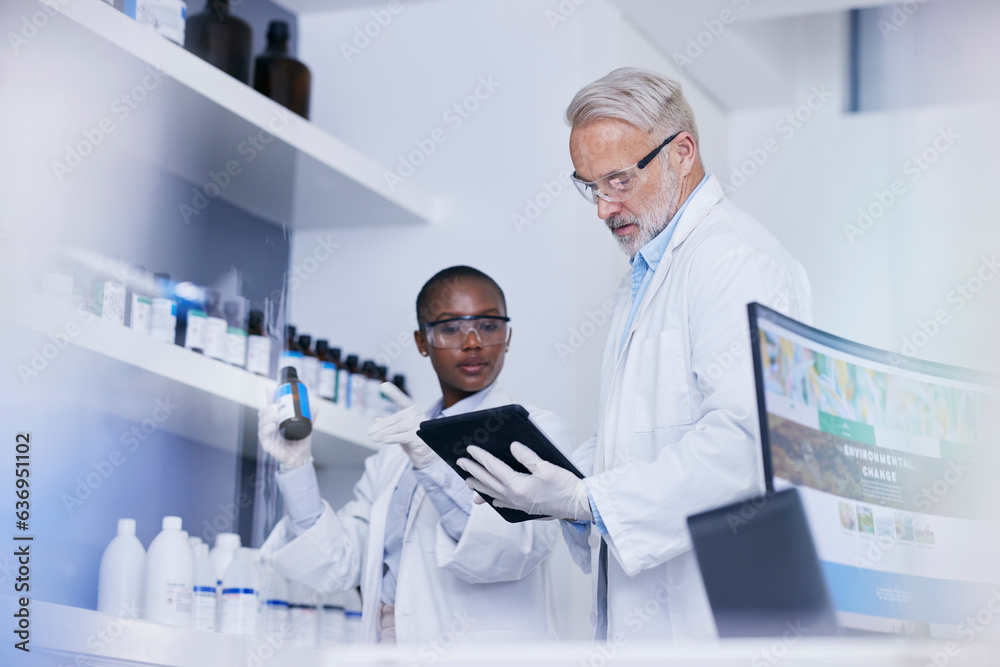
[{"left": 253, "top": 21, "right": 312, "bottom": 118}]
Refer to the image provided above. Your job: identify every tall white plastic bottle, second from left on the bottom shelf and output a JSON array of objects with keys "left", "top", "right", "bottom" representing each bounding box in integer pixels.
[{"left": 144, "top": 516, "right": 194, "bottom": 628}]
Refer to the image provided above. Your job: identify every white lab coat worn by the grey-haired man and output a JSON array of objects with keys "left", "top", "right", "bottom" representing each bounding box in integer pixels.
[{"left": 563, "top": 177, "right": 810, "bottom": 643}]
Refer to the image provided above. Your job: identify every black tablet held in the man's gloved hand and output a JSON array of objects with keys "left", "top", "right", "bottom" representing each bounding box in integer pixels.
[{"left": 417, "top": 405, "right": 583, "bottom": 523}]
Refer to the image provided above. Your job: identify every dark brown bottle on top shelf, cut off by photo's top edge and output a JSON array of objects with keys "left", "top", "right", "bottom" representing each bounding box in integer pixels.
[{"left": 184, "top": 0, "right": 253, "bottom": 84}]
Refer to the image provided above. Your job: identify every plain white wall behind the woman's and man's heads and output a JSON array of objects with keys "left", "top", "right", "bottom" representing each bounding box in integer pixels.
[{"left": 290, "top": 0, "right": 727, "bottom": 638}]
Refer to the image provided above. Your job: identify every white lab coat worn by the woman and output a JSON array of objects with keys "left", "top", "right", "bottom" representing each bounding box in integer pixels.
[{"left": 261, "top": 383, "right": 573, "bottom": 657}]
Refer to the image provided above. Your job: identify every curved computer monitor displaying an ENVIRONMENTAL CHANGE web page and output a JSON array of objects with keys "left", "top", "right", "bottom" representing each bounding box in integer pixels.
[{"left": 749, "top": 304, "right": 1000, "bottom": 639}]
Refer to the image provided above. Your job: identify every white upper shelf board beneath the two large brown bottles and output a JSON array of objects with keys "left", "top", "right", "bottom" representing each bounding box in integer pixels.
[{"left": 44, "top": 0, "right": 435, "bottom": 228}]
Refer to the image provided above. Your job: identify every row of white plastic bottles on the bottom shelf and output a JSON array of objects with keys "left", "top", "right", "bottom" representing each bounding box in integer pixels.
[{"left": 97, "top": 516, "right": 361, "bottom": 648}]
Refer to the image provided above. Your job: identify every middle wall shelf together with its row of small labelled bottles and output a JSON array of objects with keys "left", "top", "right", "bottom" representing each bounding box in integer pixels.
[{"left": 9, "top": 247, "right": 406, "bottom": 468}]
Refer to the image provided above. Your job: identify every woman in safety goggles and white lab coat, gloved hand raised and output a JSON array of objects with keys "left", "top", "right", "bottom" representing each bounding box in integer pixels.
[{"left": 259, "top": 267, "right": 573, "bottom": 657}]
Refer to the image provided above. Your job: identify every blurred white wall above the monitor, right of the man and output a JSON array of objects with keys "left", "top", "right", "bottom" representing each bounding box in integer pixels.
[{"left": 726, "top": 8, "right": 1000, "bottom": 370}]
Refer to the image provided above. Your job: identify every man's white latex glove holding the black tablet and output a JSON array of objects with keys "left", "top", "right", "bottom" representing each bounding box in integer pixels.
[{"left": 458, "top": 442, "right": 594, "bottom": 521}]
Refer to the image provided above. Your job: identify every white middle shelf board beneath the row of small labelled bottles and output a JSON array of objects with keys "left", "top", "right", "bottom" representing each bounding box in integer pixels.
[{"left": 3, "top": 290, "right": 378, "bottom": 467}]
